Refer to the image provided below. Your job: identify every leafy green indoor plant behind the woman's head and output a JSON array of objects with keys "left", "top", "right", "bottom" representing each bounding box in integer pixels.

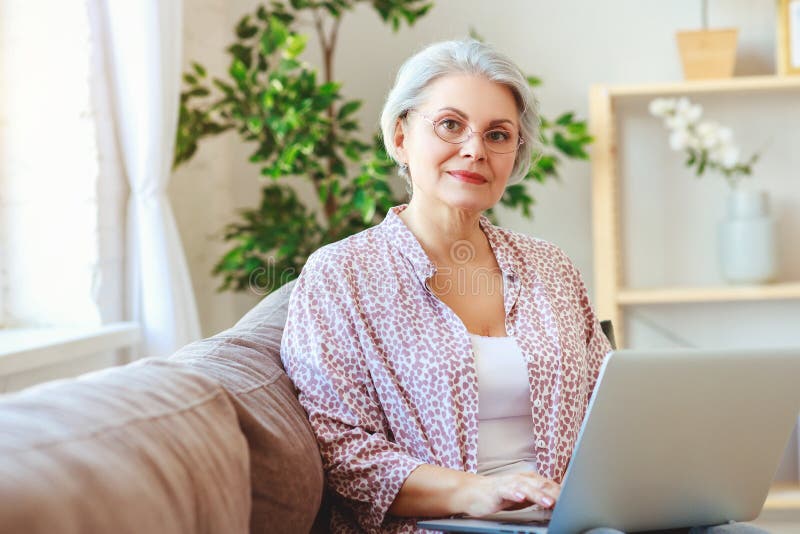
[{"left": 174, "top": 0, "right": 591, "bottom": 294}]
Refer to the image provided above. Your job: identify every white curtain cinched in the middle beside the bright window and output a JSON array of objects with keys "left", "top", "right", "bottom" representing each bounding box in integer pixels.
[{"left": 98, "top": 0, "right": 200, "bottom": 357}]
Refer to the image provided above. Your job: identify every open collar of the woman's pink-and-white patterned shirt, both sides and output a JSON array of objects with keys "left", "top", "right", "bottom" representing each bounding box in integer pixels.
[{"left": 378, "top": 204, "right": 517, "bottom": 281}]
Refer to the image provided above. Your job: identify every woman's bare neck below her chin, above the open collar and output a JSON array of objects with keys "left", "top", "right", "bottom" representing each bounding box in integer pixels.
[{"left": 399, "top": 195, "right": 489, "bottom": 266}]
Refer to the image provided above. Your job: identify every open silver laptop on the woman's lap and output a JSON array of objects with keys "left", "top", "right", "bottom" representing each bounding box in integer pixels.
[{"left": 417, "top": 348, "right": 800, "bottom": 534}]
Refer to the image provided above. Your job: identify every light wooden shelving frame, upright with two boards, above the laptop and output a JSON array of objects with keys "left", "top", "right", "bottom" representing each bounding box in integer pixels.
[{"left": 589, "top": 76, "right": 800, "bottom": 348}]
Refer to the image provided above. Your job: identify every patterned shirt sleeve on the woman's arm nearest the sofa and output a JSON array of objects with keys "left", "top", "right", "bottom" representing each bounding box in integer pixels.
[{"left": 281, "top": 255, "right": 424, "bottom": 532}]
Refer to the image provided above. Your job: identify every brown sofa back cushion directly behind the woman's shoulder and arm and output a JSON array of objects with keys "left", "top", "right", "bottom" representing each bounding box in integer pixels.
[{"left": 170, "top": 282, "right": 324, "bottom": 533}]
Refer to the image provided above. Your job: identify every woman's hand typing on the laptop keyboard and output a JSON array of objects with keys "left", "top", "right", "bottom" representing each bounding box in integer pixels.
[{"left": 459, "top": 472, "right": 561, "bottom": 517}]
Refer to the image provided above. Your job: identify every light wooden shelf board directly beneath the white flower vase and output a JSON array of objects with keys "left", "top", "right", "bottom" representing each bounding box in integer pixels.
[{"left": 617, "top": 282, "right": 800, "bottom": 305}]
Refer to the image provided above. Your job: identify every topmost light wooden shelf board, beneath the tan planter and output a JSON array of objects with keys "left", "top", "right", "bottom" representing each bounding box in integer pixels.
[{"left": 596, "top": 76, "right": 800, "bottom": 98}]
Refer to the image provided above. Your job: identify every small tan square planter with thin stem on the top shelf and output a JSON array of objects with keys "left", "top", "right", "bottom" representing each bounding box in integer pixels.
[{"left": 676, "top": 0, "right": 739, "bottom": 80}]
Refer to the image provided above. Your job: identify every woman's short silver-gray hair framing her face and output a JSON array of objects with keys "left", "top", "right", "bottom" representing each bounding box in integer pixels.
[{"left": 381, "top": 39, "right": 542, "bottom": 193}]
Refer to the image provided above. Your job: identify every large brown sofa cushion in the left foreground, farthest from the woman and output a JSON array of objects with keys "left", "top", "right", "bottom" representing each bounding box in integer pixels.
[{"left": 0, "top": 359, "right": 250, "bottom": 534}]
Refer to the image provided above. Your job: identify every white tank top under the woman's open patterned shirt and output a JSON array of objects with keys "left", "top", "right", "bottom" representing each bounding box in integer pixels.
[{"left": 470, "top": 333, "right": 535, "bottom": 475}]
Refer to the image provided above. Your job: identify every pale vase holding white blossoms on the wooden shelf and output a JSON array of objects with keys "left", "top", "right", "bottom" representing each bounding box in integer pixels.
[{"left": 650, "top": 98, "right": 777, "bottom": 283}]
